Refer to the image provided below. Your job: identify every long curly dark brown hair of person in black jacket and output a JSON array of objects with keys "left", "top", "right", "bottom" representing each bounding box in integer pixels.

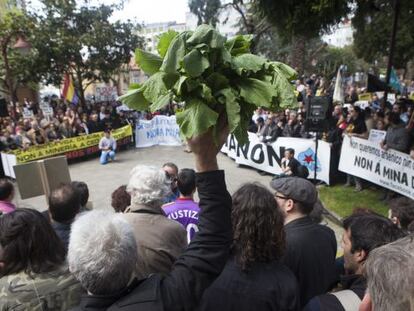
[{"left": 232, "top": 183, "right": 285, "bottom": 271}]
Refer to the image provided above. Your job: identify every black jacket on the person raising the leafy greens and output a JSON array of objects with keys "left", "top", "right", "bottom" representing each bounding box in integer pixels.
[{"left": 74, "top": 171, "right": 232, "bottom": 311}]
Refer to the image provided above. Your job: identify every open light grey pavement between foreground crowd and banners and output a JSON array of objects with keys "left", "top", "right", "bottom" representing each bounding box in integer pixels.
[{"left": 16, "top": 146, "right": 342, "bottom": 251}]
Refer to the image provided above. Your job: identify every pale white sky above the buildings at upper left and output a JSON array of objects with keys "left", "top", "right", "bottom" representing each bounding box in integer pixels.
[{"left": 27, "top": 0, "right": 189, "bottom": 24}]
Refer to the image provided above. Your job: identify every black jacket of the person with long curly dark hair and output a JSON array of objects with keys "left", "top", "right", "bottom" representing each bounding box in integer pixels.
[{"left": 198, "top": 259, "right": 299, "bottom": 311}]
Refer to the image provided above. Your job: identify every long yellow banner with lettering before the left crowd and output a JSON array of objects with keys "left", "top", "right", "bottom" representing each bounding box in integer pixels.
[{"left": 3, "top": 125, "right": 132, "bottom": 164}]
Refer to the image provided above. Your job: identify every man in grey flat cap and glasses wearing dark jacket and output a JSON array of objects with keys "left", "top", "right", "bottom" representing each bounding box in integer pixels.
[{"left": 270, "top": 177, "right": 338, "bottom": 307}]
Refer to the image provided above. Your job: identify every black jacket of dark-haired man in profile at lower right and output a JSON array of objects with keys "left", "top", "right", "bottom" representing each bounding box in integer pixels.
[{"left": 303, "top": 274, "right": 367, "bottom": 311}]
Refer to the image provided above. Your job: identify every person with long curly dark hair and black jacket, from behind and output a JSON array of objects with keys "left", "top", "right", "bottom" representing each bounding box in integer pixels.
[{"left": 199, "top": 183, "right": 299, "bottom": 311}]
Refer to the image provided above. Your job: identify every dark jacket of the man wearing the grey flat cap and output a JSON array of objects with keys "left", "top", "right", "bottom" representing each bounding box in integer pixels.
[{"left": 283, "top": 217, "right": 338, "bottom": 307}]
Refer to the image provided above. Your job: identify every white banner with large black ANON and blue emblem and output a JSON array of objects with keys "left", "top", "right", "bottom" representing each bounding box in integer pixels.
[{"left": 221, "top": 133, "right": 331, "bottom": 185}]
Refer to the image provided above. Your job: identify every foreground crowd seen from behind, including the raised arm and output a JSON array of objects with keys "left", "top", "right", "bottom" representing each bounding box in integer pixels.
[{"left": 0, "top": 125, "right": 414, "bottom": 311}]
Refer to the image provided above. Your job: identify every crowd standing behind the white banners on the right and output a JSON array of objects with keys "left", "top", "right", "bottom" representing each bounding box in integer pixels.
[{"left": 249, "top": 75, "right": 414, "bottom": 195}]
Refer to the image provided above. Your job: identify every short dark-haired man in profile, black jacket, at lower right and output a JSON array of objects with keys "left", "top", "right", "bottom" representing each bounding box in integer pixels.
[{"left": 304, "top": 214, "right": 403, "bottom": 311}]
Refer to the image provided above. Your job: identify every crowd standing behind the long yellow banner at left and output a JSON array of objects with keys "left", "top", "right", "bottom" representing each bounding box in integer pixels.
[{"left": 0, "top": 98, "right": 133, "bottom": 151}]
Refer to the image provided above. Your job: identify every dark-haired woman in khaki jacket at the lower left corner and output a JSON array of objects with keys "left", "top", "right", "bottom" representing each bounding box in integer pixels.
[{"left": 0, "top": 208, "right": 81, "bottom": 311}]
